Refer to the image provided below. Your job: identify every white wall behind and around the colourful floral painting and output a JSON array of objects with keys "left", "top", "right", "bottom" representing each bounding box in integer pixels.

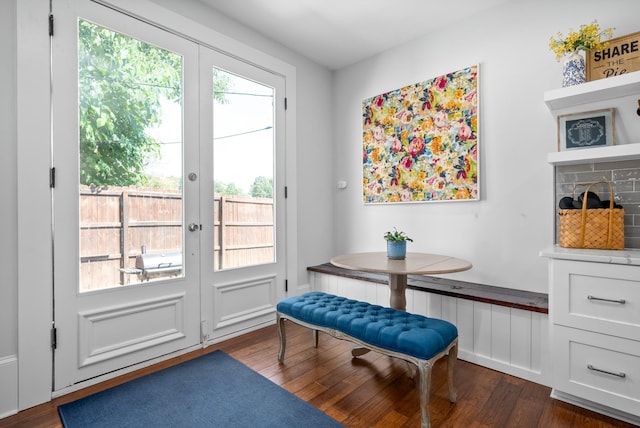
[{"left": 332, "top": 0, "right": 640, "bottom": 292}]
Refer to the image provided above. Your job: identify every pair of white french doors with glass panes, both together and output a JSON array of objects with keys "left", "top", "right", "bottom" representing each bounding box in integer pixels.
[{"left": 52, "top": 0, "right": 285, "bottom": 390}]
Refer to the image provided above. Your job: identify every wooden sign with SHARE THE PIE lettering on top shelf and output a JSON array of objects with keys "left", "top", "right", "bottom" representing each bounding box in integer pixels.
[{"left": 587, "top": 32, "right": 640, "bottom": 82}]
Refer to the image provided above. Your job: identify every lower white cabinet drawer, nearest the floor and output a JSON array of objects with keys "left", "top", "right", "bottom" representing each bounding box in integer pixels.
[{"left": 553, "top": 327, "right": 640, "bottom": 416}]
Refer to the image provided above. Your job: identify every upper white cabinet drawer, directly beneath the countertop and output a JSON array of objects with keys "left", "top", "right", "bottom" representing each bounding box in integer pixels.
[{"left": 551, "top": 260, "right": 640, "bottom": 340}]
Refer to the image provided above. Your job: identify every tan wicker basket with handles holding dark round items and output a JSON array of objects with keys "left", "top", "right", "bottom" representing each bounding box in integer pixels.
[{"left": 558, "top": 181, "right": 624, "bottom": 250}]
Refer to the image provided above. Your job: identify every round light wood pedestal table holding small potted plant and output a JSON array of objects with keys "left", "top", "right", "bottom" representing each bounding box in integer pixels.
[{"left": 331, "top": 251, "right": 473, "bottom": 311}]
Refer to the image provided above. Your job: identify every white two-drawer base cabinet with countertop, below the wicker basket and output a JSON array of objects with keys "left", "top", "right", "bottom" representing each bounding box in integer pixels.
[{"left": 542, "top": 248, "right": 640, "bottom": 424}]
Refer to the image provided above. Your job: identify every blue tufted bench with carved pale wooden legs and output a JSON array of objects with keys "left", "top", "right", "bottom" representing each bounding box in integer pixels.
[{"left": 276, "top": 292, "right": 458, "bottom": 428}]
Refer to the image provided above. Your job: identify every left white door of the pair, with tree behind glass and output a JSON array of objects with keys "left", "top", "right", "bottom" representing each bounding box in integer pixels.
[{"left": 52, "top": 0, "right": 201, "bottom": 390}]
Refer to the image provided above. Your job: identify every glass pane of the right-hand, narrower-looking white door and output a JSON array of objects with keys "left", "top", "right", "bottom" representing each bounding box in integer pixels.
[{"left": 213, "top": 68, "right": 275, "bottom": 270}]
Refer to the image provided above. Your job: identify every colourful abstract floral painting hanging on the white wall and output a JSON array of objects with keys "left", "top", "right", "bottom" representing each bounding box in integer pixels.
[{"left": 362, "top": 65, "right": 479, "bottom": 203}]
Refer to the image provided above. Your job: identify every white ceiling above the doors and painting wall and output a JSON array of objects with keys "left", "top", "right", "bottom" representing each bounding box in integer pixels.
[{"left": 199, "top": 0, "right": 512, "bottom": 70}]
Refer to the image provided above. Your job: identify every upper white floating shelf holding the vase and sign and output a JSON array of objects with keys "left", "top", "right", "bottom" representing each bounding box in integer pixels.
[{"left": 544, "top": 71, "right": 640, "bottom": 110}]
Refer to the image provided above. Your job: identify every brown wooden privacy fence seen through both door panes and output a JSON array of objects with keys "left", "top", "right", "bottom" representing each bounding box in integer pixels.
[{"left": 80, "top": 186, "right": 274, "bottom": 291}]
